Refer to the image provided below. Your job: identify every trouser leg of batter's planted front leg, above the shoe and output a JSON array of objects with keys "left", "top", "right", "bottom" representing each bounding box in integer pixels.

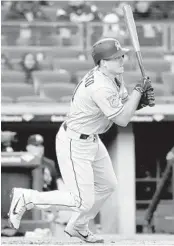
[{"left": 67, "top": 136, "right": 117, "bottom": 230}]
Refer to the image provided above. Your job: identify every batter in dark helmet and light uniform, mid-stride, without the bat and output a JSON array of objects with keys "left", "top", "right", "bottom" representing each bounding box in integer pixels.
[{"left": 9, "top": 38, "right": 155, "bottom": 243}]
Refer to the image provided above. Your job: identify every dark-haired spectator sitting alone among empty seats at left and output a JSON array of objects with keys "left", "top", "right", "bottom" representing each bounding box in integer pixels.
[{"left": 19, "top": 53, "right": 41, "bottom": 84}]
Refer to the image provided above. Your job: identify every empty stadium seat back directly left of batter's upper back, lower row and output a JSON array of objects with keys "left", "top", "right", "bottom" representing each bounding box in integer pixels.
[{"left": 43, "top": 83, "right": 75, "bottom": 101}]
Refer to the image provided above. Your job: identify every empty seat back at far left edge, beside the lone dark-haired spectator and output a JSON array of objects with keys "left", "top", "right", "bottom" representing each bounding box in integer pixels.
[{"left": 1, "top": 70, "right": 25, "bottom": 83}]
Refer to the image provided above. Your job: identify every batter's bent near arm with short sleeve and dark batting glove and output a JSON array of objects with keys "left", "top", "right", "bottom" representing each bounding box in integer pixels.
[{"left": 92, "top": 76, "right": 154, "bottom": 127}]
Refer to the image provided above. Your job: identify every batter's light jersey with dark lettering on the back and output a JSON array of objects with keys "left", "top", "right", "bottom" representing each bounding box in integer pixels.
[{"left": 66, "top": 66, "right": 128, "bottom": 135}]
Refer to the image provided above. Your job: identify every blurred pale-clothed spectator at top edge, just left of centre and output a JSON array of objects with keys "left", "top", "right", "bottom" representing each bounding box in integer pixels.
[{"left": 56, "top": 0, "right": 101, "bottom": 23}]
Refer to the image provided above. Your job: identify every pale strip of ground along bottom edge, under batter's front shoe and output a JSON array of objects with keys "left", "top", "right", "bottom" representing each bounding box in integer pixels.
[{"left": 1, "top": 234, "right": 174, "bottom": 246}]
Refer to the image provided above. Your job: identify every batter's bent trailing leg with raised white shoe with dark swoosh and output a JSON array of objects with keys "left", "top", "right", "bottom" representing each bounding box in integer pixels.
[{"left": 9, "top": 127, "right": 97, "bottom": 229}]
